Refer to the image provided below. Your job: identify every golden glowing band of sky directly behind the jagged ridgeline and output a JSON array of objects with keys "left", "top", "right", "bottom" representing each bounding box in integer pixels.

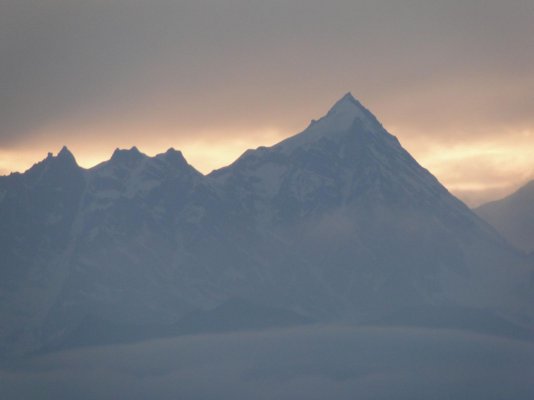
[{"left": 0, "top": 126, "right": 534, "bottom": 205}]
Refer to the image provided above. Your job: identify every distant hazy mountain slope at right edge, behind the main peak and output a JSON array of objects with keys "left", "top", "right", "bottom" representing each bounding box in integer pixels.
[{"left": 475, "top": 181, "right": 534, "bottom": 252}]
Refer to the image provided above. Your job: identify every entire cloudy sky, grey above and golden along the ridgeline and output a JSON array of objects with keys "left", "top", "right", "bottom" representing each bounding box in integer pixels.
[{"left": 0, "top": 0, "right": 534, "bottom": 205}]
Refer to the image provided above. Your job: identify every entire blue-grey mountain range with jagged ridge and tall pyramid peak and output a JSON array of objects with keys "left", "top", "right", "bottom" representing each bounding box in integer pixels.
[{"left": 0, "top": 94, "right": 532, "bottom": 351}]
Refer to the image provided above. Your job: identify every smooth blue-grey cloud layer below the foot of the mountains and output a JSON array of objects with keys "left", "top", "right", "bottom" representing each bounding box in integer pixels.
[{"left": 0, "top": 327, "right": 534, "bottom": 400}]
